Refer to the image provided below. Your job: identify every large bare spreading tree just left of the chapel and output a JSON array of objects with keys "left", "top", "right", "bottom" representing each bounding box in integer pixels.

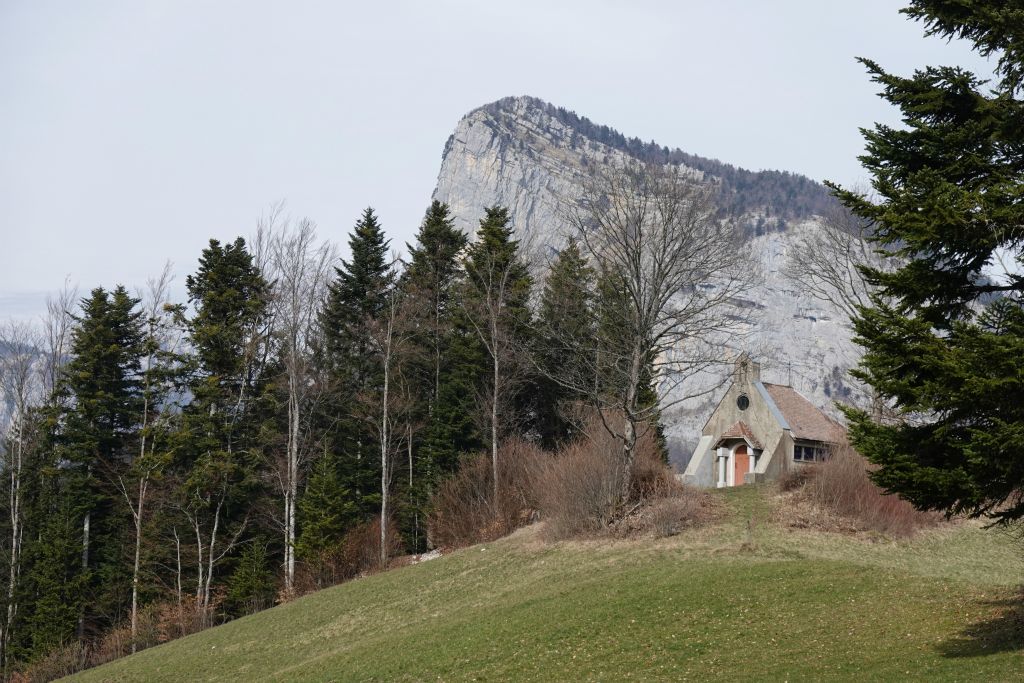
[{"left": 554, "top": 162, "right": 751, "bottom": 499}]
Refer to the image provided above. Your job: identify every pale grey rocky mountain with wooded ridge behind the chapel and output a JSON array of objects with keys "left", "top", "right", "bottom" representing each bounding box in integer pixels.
[{"left": 434, "top": 97, "right": 857, "bottom": 464}]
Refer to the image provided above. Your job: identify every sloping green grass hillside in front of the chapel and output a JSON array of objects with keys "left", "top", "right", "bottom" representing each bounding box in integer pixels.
[{"left": 75, "top": 487, "right": 1024, "bottom": 681}]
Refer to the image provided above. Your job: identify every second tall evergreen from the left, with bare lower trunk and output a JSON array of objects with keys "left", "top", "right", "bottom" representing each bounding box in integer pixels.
[{"left": 175, "top": 238, "right": 269, "bottom": 606}]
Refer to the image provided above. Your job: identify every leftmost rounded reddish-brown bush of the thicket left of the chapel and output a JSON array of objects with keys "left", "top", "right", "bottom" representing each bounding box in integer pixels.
[{"left": 428, "top": 438, "right": 551, "bottom": 548}]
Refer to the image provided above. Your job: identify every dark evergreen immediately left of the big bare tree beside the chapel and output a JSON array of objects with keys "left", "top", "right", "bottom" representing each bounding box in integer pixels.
[{"left": 537, "top": 240, "right": 597, "bottom": 449}]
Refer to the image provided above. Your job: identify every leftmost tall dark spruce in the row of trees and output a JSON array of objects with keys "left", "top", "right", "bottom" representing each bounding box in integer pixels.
[{"left": 44, "top": 287, "right": 143, "bottom": 638}]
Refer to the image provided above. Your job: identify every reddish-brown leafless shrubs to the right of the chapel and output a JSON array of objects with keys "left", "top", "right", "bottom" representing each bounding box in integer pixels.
[{"left": 798, "top": 443, "right": 944, "bottom": 537}]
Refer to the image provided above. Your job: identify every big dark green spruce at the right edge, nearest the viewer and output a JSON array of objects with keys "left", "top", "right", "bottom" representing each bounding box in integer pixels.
[{"left": 836, "top": 0, "right": 1024, "bottom": 522}]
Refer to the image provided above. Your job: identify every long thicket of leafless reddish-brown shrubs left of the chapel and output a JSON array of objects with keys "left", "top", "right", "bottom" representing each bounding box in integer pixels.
[{"left": 429, "top": 416, "right": 714, "bottom": 548}]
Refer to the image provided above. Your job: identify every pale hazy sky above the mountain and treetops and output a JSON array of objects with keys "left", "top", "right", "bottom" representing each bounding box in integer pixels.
[{"left": 0, "top": 0, "right": 985, "bottom": 318}]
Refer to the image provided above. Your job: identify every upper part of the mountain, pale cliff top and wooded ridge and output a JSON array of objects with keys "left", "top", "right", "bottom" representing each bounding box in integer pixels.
[{"left": 434, "top": 96, "right": 835, "bottom": 246}]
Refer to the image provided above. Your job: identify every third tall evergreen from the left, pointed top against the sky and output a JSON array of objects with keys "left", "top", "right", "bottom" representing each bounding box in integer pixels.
[{"left": 321, "top": 208, "right": 394, "bottom": 518}]
